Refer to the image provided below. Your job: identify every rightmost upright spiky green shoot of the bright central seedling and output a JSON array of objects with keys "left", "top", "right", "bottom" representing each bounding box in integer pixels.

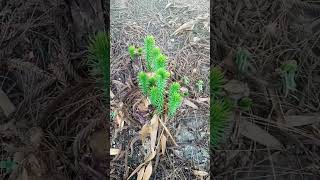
[{"left": 168, "top": 82, "right": 182, "bottom": 119}]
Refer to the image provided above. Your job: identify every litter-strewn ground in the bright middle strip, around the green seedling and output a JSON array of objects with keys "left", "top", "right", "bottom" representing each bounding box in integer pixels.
[{"left": 110, "top": 0, "right": 210, "bottom": 179}]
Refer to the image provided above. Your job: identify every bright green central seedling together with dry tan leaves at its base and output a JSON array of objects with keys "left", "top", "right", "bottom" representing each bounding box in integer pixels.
[{"left": 129, "top": 36, "right": 183, "bottom": 179}]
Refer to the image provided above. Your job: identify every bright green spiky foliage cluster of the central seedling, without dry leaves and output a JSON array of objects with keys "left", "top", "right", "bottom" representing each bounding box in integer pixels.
[{"left": 132, "top": 36, "right": 182, "bottom": 119}]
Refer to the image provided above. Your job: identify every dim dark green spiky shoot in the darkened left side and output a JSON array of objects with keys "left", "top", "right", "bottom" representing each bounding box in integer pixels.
[{"left": 88, "top": 32, "right": 110, "bottom": 98}]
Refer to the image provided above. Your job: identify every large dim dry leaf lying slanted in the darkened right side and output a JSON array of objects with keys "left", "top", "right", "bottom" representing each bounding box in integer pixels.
[{"left": 239, "top": 119, "right": 283, "bottom": 149}]
